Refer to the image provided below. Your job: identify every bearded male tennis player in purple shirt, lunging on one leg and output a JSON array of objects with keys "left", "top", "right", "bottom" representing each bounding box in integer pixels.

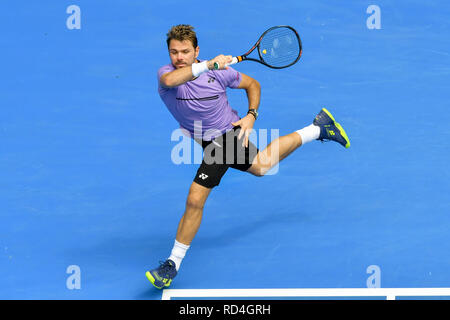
[{"left": 146, "top": 25, "right": 350, "bottom": 289}]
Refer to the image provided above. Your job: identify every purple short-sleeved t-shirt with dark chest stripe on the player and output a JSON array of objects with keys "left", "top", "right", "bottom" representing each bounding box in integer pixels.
[{"left": 158, "top": 64, "right": 242, "bottom": 140}]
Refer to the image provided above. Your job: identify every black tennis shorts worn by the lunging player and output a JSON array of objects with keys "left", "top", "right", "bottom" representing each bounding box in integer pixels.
[{"left": 194, "top": 126, "right": 259, "bottom": 188}]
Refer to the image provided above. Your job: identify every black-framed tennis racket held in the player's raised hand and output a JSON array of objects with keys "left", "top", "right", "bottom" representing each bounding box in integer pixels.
[{"left": 214, "top": 26, "right": 302, "bottom": 70}]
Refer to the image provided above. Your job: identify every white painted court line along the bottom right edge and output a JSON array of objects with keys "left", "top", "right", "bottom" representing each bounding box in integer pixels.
[{"left": 161, "top": 288, "right": 450, "bottom": 300}]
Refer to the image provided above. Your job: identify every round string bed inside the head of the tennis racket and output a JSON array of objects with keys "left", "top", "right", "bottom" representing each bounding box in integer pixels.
[{"left": 259, "top": 28, "right": 300, "bottom": 67}]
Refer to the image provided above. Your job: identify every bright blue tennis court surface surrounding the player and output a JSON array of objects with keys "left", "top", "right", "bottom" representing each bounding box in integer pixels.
[{"left": 0, "top": 0, "right": 450, "bottom": 299}]
